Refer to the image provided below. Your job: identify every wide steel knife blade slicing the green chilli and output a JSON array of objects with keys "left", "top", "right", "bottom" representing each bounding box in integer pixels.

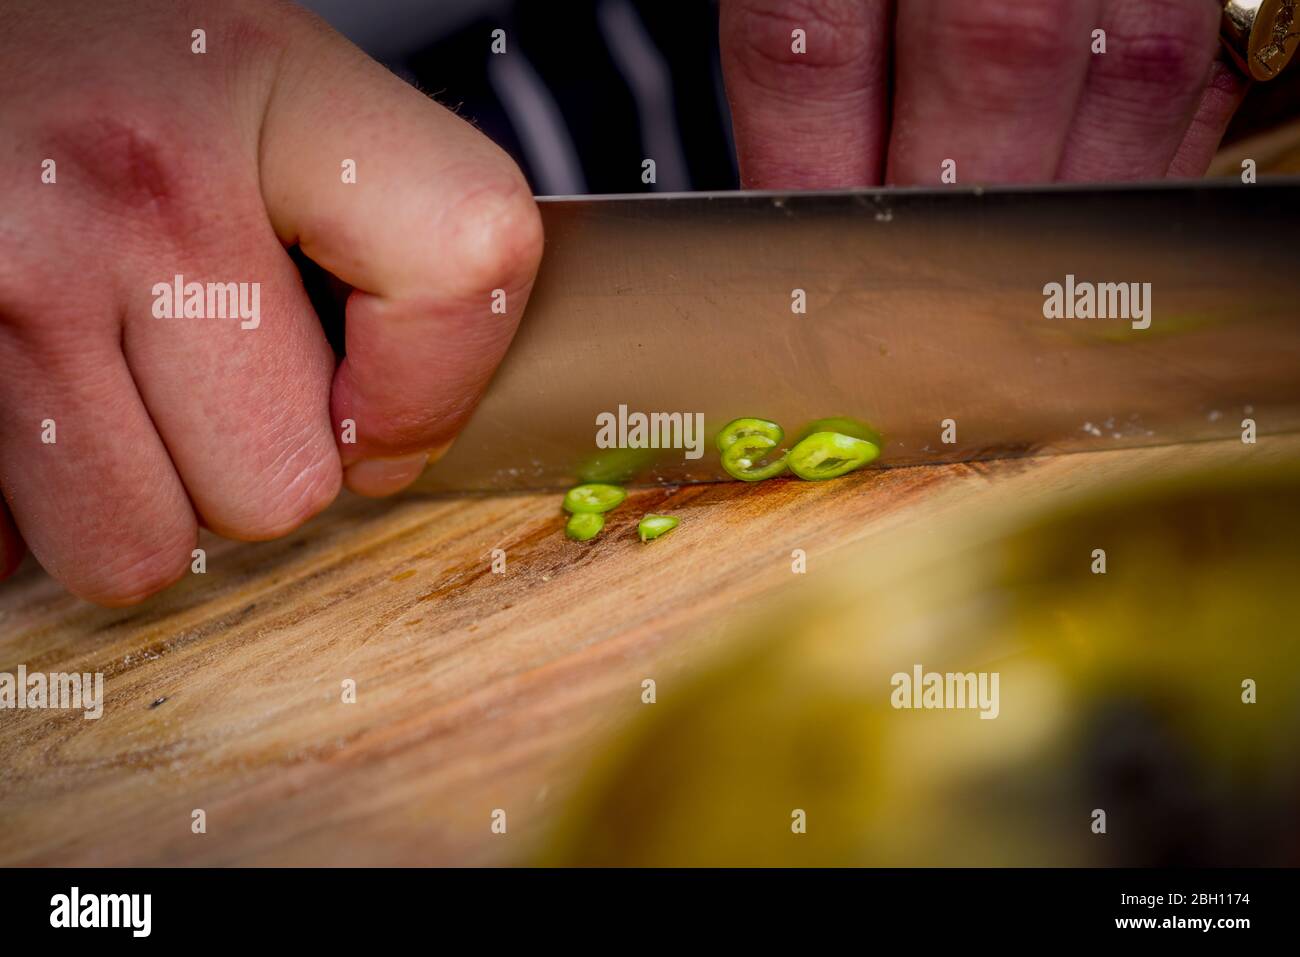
[{"left": 420, "top": 178, "right": 1300, "bottom": 492}]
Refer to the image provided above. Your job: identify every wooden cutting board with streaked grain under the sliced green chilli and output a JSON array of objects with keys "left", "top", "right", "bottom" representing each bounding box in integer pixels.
[{"left": 0, "top": 436, "right": 1300, "bottom": 865}]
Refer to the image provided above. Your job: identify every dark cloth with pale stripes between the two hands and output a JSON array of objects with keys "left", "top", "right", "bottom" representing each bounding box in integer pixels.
[{"left": 303, "top": 0, "right": 738, "bottom": 195}]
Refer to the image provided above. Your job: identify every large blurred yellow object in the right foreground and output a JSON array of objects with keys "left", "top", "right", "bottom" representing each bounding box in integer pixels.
[{"left": 542, "top": 455, "right": 1300, "bottom": 866}]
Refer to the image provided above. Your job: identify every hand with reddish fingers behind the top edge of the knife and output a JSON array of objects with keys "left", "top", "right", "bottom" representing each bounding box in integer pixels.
[{"left": 720, "top": 0, "right": 1245, "bottom": 189}]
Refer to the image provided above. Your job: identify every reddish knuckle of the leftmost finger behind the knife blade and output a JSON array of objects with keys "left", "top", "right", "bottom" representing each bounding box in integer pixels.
[{"left": 722, "top": 0, "right": 879, "bottom": 95}]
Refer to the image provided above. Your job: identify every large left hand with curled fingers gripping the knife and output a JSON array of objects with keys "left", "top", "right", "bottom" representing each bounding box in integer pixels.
[{"left": 0, "top": 0, "right": 542, "bottom": 605}]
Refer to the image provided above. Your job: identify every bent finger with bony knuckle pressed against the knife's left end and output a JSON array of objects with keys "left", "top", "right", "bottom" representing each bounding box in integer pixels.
[{"left": 261, "top": 11, "right": 542, "bottom": 494}]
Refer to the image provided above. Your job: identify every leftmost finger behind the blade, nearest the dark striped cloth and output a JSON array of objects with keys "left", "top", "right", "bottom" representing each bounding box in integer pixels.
[{"left": 719, "top": 0, "right": 892, "bottom": 190}]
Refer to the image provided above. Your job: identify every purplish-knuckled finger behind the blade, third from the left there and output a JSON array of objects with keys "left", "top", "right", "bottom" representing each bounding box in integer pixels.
[{"left": 1058, "top": 0, "right": 1221, "bottom": 182}]
